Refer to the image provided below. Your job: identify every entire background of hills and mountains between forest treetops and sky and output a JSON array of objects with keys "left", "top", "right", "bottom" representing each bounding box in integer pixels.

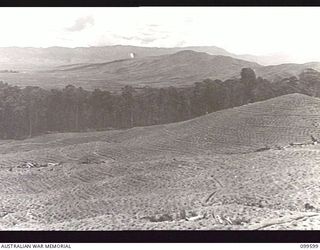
[{"left": 0, "top": 46, "right": 320, "bottom": 91}]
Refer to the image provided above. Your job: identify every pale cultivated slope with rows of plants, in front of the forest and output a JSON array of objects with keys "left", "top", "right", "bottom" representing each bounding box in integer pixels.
[{"left": 0, "top": 94, "right": 320, "bottom": 230}]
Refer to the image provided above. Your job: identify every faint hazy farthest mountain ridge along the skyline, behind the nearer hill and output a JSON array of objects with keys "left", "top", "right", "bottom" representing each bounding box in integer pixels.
[{"left": 0, "top": 45, "right": 314, "bottom": 70}]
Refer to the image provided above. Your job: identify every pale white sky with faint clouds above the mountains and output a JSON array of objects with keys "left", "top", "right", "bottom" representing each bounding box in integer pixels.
[{"left": 0, "top": 7, "right": 320, "bottom": 63}]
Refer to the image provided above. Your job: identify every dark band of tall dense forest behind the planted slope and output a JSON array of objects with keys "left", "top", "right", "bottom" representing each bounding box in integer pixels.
[{"left": 0, "top": 68, "right": 320, "bottom": 139}]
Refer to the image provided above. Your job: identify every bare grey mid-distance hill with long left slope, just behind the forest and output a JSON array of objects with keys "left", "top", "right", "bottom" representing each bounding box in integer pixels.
[{"left": 0, "top": 50, "right": 259, "bottom": 91}]
